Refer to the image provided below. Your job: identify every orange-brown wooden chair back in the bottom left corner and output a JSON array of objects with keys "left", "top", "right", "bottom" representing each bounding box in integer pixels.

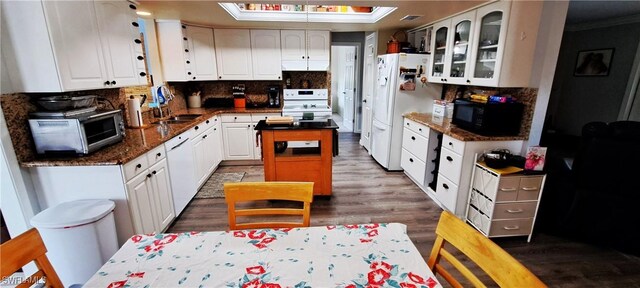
[{"left": 0, "top": 228, "right": 64, "bottom": 288}]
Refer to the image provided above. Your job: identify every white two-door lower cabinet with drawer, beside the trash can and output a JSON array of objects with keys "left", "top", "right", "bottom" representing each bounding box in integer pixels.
[{"left": 123, "top": 145, "right": 175, "bottom": 234}]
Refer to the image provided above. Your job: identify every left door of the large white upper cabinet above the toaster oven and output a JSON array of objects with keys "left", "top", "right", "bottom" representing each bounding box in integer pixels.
[{"left": 42, "top": 1, "right": 110, "bottom": 91}]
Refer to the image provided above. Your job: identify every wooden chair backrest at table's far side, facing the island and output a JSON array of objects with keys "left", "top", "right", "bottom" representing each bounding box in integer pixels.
[{"left": 224, "top": 182, "right": 313, "bottom": 230}]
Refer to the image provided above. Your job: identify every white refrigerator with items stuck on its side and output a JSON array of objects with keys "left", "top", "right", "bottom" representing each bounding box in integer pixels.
[{"left": 371, "top": 53, "right": 442, "bottom": 171}]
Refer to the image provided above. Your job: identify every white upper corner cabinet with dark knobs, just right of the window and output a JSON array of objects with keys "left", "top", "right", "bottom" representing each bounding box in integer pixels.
[{"left": 156, "top": 20, "right": 218, "bottom": 81}]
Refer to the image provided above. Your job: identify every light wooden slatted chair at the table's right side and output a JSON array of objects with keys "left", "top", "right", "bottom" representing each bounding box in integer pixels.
[{"left": 427, "top": 211, "right": 547, "bottom": 287}]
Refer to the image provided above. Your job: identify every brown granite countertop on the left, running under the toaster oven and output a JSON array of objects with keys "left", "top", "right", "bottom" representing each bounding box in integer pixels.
[{"left": 20, "top": 108, "right": 282, "bottom": 167}]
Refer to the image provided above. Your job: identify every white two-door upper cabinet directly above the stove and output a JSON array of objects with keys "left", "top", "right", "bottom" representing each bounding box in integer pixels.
[{"left": 280, "top": 30, "right": 331, "bottom": 71}]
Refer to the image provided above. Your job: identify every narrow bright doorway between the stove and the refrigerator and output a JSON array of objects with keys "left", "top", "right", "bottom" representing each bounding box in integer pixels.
[{"left": 331, "top": 44, "right": 360, "bottom": 133}]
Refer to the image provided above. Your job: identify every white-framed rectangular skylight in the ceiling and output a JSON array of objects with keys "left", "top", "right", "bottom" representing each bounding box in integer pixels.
[{"left": 220, "top": 3, "right": 397, "bottom": 23}]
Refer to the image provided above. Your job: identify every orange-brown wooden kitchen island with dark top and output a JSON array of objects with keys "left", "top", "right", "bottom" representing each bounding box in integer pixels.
[{"left": 255, "top": 119, "right": 338, "bottom": 196}]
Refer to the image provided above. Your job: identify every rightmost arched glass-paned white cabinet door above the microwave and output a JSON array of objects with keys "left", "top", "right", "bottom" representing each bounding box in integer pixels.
[{"left": 469, "top": 1, "right": 511, "bottom": 87}]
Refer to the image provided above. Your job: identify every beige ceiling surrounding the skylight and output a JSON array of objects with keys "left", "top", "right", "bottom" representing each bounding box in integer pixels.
[{"left": 138, "top": 0, "right": 488, "bottom": 31}]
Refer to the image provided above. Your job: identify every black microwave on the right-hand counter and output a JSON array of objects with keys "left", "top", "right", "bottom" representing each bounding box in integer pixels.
[{"left": 451, "top": 99, "right": 524, "bottom": 136}]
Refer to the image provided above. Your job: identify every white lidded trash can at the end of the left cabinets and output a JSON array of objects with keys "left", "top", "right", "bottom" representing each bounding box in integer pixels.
[{"left": 31, "top": 200, "right": 118, "bottom": 287}]
